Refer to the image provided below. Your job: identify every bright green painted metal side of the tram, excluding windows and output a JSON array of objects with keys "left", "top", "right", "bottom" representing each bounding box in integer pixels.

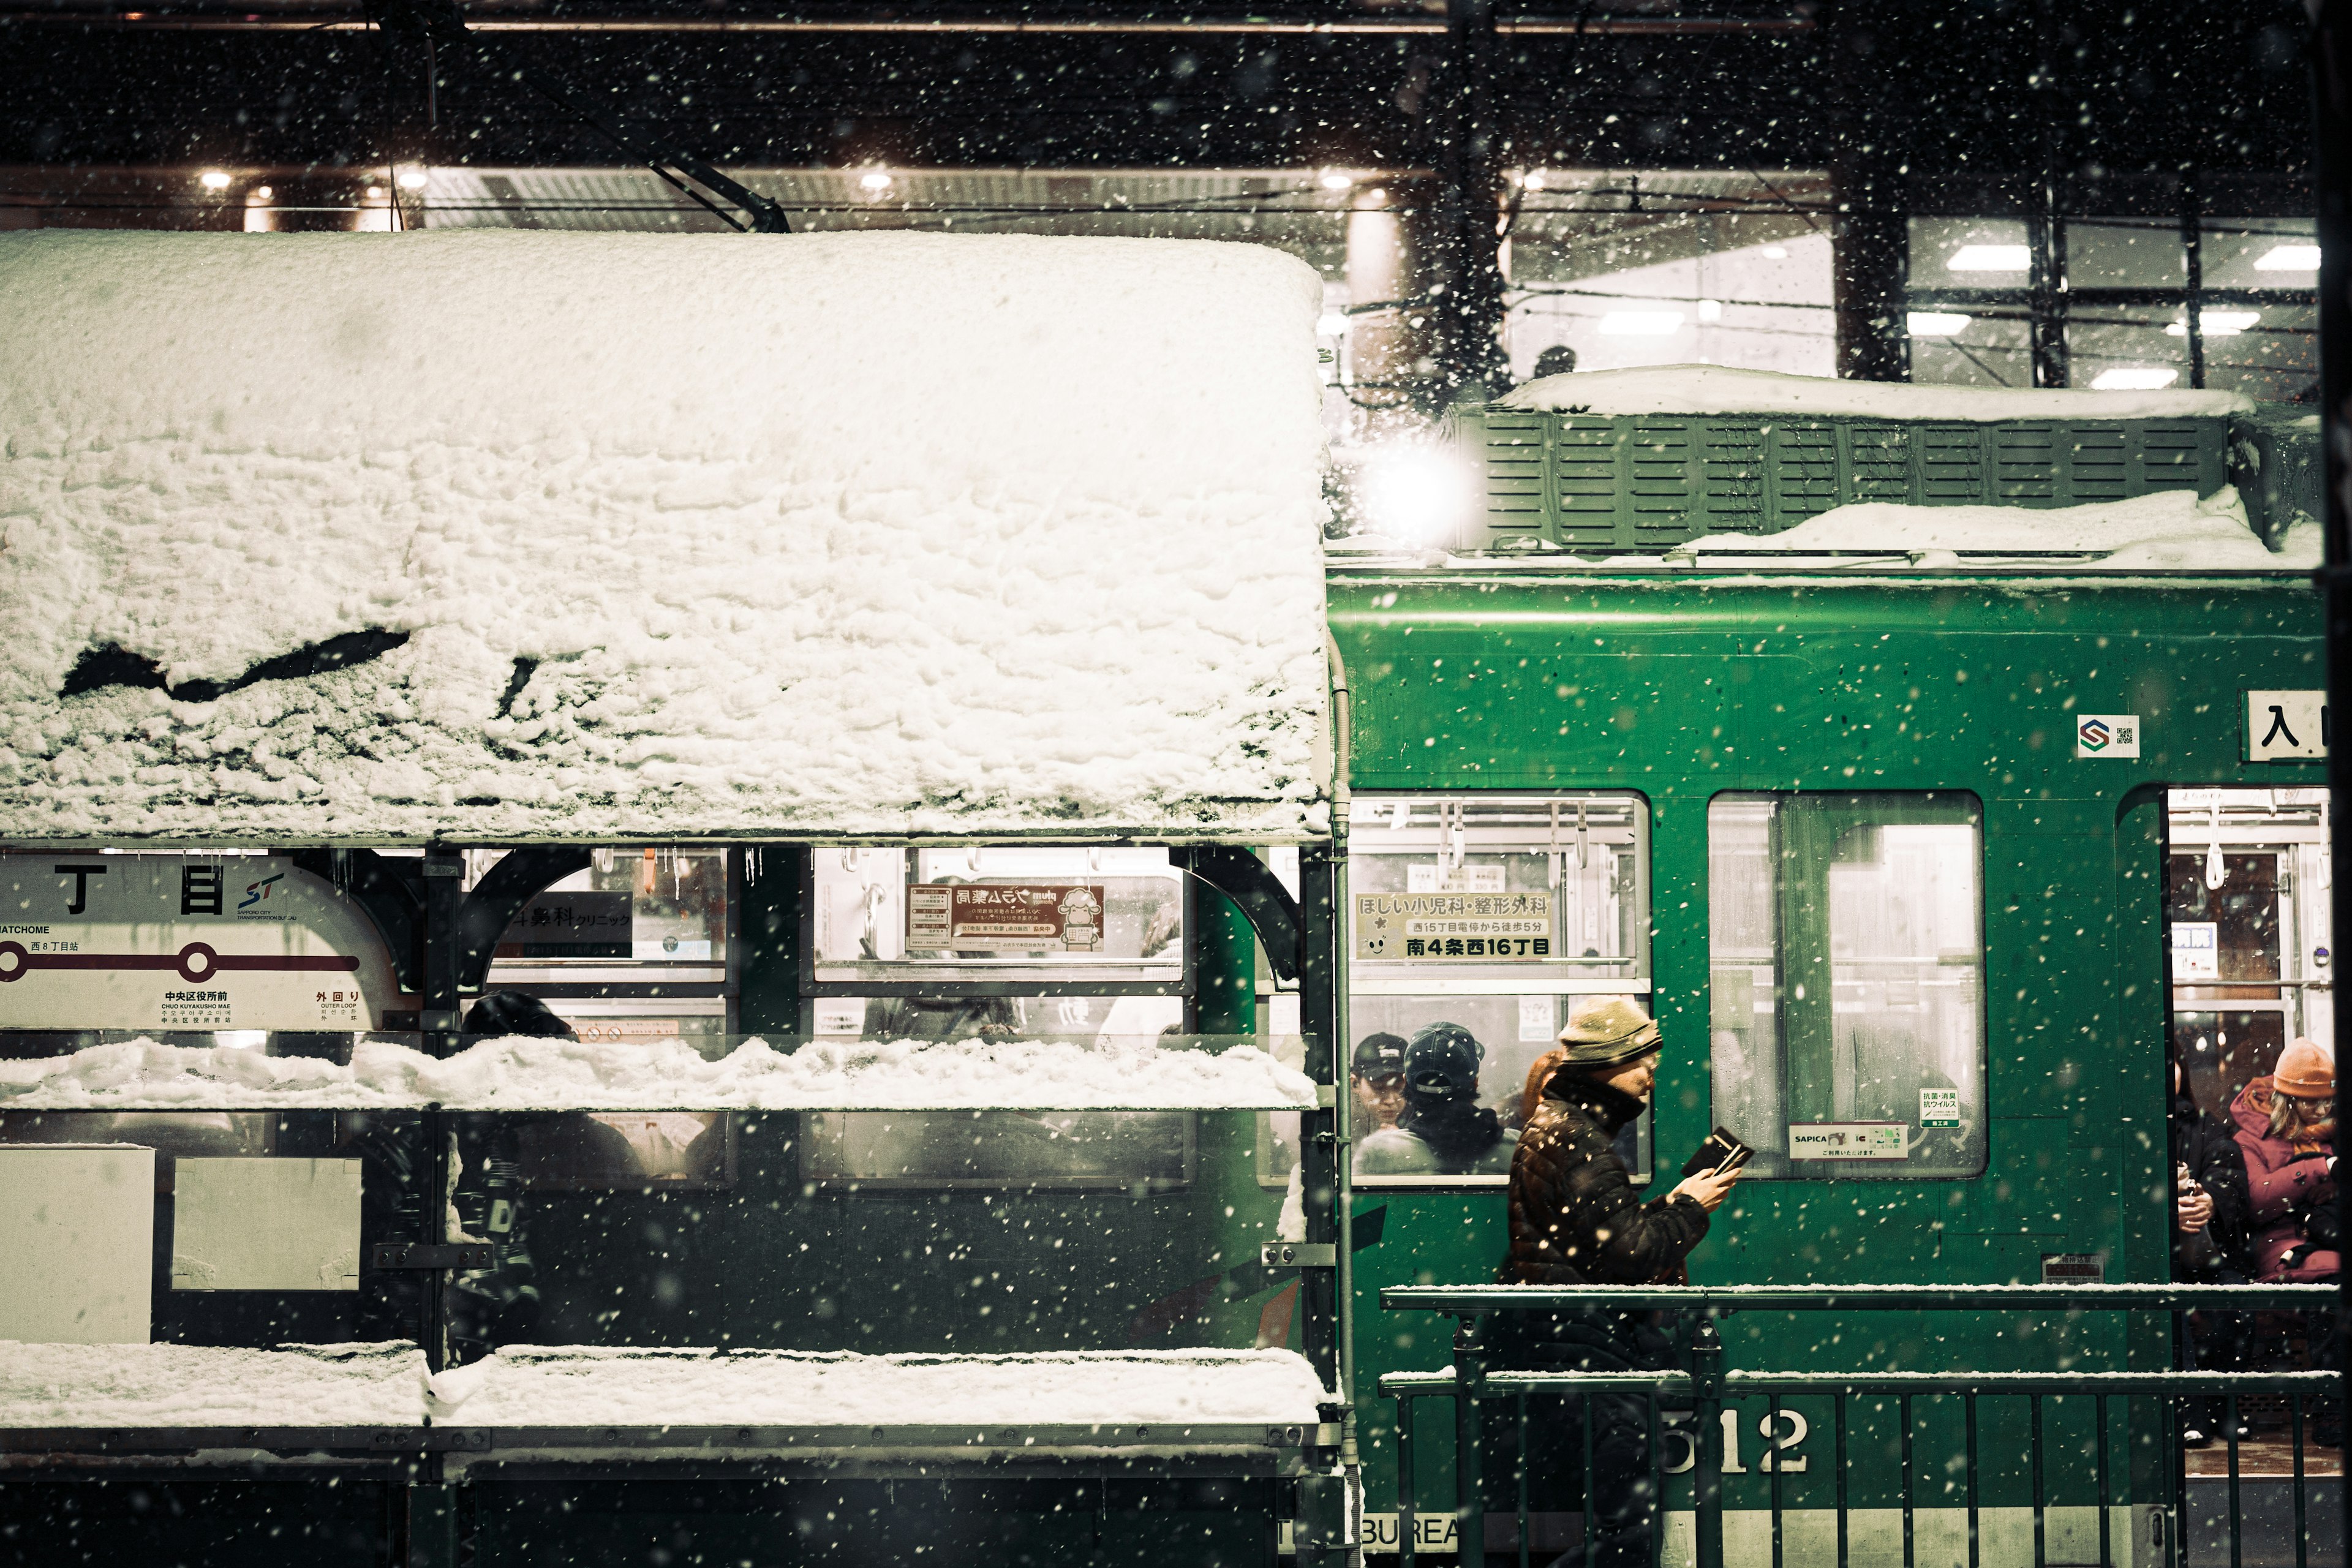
[{"left": 1331, "top": 567, "right": 2326, "bottom": 1512}]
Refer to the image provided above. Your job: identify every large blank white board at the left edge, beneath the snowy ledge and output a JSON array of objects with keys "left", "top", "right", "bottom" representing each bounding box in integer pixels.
[{"left": 0, "top": 1142, "right": 155, "bottom": 1344}]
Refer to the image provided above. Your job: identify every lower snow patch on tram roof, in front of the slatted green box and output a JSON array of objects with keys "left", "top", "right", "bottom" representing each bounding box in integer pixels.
[{"left": 1682, "top": 486, "right": 2319, "bottom": 571}]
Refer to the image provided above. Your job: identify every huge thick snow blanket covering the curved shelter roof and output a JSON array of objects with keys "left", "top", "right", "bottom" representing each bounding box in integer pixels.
[{"left": 0, "top": 233, "right": 1324, "bottom": 842}]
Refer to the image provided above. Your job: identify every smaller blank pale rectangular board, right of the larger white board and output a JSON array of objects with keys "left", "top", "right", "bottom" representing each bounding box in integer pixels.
[{"left": 172, "top": 1154, "right": 360, "bottom": 1291}]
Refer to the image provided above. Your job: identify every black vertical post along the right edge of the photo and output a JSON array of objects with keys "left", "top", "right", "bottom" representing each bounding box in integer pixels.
[{"left": 2310, "top": 0, "right": 2352, "bottom": 1542}]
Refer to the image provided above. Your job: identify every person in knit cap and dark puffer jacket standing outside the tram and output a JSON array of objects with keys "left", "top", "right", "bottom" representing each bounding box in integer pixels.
[{"left": 1484, "top": 997, "right": 1741, "bottom": 1568}]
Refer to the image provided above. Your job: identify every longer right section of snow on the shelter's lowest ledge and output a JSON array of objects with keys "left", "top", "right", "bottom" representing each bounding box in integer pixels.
[{"left": 431, "top": 1347, "right": 1331, "bottom": 1427}]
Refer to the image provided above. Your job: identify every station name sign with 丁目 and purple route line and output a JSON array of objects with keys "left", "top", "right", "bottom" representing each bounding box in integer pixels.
[{"left": 0, "top": 851, "right": 417, "bottom": 1030}]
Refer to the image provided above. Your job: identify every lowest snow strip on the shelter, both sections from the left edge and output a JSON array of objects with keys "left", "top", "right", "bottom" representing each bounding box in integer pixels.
[{"left": 0, "top": 1340, "right": 1329, "bottom": 1436}]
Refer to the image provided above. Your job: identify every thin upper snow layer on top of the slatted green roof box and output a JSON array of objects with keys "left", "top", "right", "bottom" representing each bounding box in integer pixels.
[{"left": 1498, "top": 364, "right": 2253, "bottom": 423}]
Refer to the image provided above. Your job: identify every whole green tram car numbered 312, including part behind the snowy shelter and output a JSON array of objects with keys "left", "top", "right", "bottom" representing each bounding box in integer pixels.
[{"left": 0, "top": 383, "right": 2340, "bottom": 1568}]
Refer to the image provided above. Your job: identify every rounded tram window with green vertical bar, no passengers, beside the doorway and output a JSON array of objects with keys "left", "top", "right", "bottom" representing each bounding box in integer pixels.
[{"left": 1708, "top": 792, "right": 1985, "bottom": 1180}]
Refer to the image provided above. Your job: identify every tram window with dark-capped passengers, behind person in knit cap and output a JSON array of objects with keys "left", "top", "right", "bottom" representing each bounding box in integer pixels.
[{"left": 1348, "top": 792, "right": 1651, "bottom": 1187}]
